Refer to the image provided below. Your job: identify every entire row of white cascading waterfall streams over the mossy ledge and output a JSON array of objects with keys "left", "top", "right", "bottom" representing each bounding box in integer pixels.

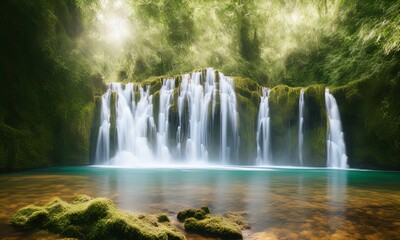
[{"left": 94, "top": 68, "right": 348, "bottom": 168}]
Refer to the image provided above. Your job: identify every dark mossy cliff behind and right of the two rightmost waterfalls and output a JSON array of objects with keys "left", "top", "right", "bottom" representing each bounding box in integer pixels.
[{"left": 262, "top": 76, "right": 400, "bottom": 170}]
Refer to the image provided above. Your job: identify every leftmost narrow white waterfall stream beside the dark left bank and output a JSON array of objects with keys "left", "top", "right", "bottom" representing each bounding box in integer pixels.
[{"left": 95, "top": 89, "right": 111, "bottom": 164}]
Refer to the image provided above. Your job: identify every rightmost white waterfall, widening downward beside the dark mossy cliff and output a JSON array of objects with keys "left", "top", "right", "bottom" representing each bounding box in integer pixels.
[{"left": 325, "top": 88, "right": 348, "bottom": 168}]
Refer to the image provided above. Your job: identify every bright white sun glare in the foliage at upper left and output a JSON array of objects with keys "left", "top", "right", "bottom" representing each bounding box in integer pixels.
[{"left": 97, "top": 0, "right": 131, "bottom": 44}]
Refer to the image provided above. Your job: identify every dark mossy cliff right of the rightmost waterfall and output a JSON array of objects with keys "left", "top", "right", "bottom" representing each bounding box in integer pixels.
[{"left": 331, "top": 73, "right": 400, "bottom": 170}]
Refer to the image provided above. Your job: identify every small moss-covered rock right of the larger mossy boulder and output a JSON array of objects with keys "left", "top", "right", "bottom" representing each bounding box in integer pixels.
[{"left": 178, "top": 207, "right": 244, "bottom": 239}]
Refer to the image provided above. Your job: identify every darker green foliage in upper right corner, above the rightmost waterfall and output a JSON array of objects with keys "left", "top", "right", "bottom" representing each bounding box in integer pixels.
[{"left": 283, "top": 0, "right": 400, "bottom": 86}]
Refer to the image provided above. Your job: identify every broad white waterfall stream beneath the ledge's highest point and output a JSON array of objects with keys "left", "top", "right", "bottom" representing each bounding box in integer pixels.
[{"left": 177, "top": 69, "right": 216, "bottom": 162}]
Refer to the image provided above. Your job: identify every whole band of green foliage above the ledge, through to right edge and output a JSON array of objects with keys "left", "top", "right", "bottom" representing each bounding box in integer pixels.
[{"left": 85, "top": 0, "right": 400, "bottom": 86}]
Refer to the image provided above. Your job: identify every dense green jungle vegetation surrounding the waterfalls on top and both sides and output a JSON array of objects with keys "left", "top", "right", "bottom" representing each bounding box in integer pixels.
[{"left": 0, "top": 0, "right": 400, "bottom": 170}]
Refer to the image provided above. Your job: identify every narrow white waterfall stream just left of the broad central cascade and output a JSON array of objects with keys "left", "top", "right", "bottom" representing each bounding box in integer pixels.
[{"left": 157, "top": 79, "right": 175, "bottom": 161}]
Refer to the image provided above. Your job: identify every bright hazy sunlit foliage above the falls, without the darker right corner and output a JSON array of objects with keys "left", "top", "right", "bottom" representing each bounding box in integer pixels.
[{"left": 73, "top": 0, "right": 338, "bottom": 85}]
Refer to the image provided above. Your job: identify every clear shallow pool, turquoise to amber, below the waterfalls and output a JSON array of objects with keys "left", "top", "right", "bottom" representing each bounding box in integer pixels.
[{"left": 0, "top": 167, "right": 400, "bottom": 239}]
